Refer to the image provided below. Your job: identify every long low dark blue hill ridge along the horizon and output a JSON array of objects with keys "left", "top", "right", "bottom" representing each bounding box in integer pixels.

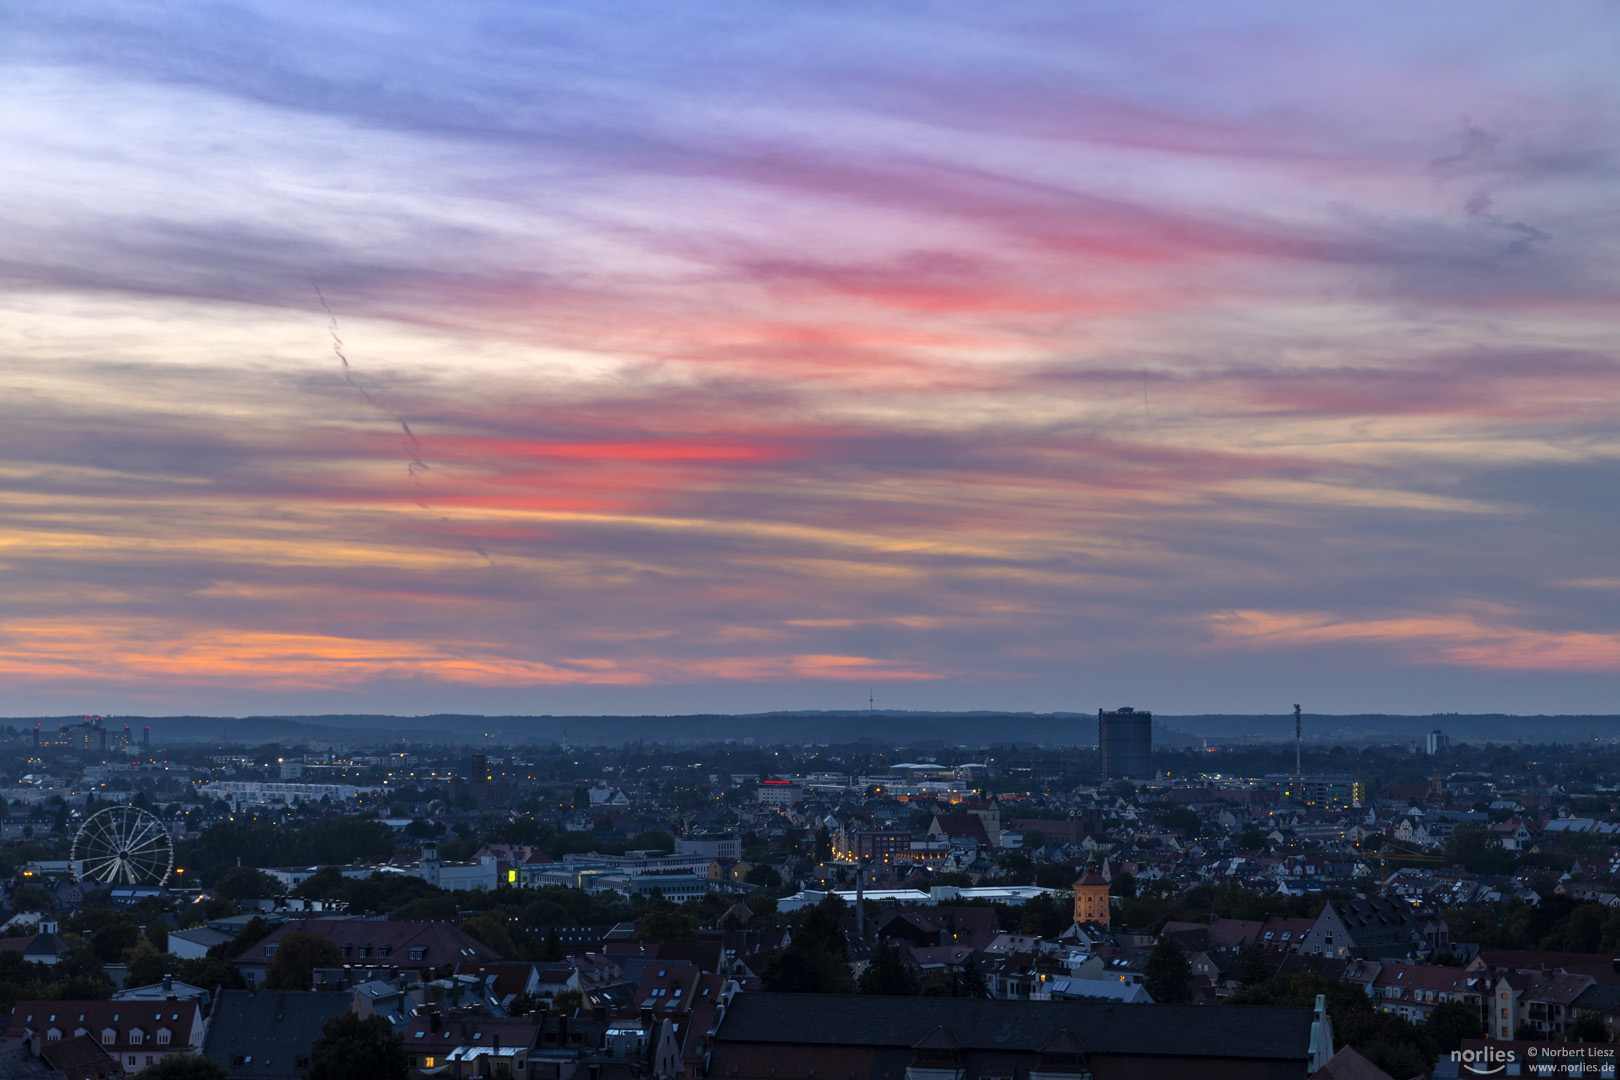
[{"left": 6, "top": 709, "right": 1620, "bottom": 746}]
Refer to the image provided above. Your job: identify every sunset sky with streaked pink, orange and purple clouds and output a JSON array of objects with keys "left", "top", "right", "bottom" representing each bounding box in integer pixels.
[{"left": 0, "top": 0, "right": 1620, "bottom": 716}]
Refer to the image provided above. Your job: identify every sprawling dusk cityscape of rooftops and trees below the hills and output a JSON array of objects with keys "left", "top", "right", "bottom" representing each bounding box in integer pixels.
[{"left": 9, "top": 706, "right": 1620, "bottom": 1080}]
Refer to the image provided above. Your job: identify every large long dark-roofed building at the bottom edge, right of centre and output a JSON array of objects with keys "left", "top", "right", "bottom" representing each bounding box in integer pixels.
[{"left": 703, "top": 993, "right": 1332, "bottom": 1080}]
